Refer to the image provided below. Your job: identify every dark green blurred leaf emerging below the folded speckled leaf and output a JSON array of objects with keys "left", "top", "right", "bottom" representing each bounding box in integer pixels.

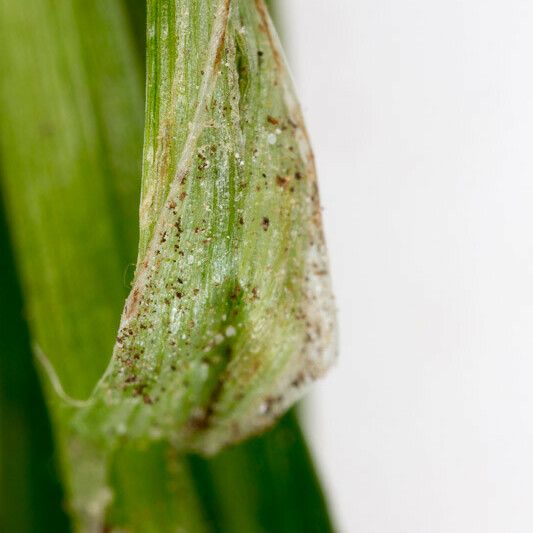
[{"left": 191, "top": 411, "right": 333, "bottom": 533}]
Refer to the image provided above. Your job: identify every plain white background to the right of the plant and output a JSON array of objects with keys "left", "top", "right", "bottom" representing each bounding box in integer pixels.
[{"left": 280, "top": 0, "right": 533, "bottom": 533}]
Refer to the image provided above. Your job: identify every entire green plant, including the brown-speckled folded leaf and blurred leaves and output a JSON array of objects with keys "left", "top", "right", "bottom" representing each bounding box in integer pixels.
[{"left": 0, "top": 0, "right": 335, "bottom": 532}]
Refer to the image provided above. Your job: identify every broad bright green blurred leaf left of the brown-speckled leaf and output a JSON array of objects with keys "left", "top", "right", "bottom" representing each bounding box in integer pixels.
[{"left": 0, "top": 0, "right": 143, "bottom": 398}]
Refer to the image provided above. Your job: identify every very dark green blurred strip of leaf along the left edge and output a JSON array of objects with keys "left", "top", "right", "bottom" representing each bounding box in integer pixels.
[{"left": 0, "top": 192, "right": 68, "bottom": 533}]
